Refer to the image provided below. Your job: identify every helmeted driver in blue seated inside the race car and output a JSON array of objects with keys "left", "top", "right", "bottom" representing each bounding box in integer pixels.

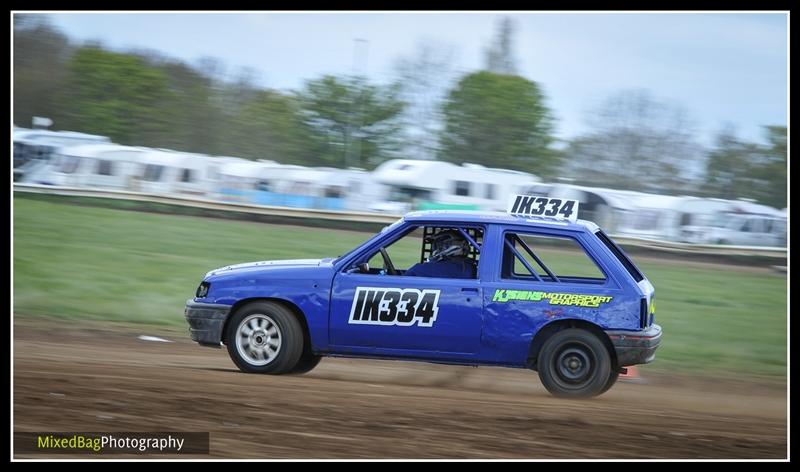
[{"left": 404, "top": 229, "right": 477, "bottom": 279}]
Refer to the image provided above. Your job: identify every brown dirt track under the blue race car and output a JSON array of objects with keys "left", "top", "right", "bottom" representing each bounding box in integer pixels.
[{"left": 14, "top": 319, "right": 787, "bottom": 459}]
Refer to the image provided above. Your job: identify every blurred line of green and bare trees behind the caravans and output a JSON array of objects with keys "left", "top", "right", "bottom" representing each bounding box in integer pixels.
[{"left": 13, "top": 15, "right": 787, "bottom": 208}]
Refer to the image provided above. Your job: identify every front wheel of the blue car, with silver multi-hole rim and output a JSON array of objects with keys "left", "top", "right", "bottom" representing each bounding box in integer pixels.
[{"left": 225, "top": 302, "right": 303, "bottom": 375}]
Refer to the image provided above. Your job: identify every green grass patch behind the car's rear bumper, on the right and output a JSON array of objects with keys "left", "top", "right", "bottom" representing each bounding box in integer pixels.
[{"left": 639, "top": 260, "right": 787, "bottom": 376}]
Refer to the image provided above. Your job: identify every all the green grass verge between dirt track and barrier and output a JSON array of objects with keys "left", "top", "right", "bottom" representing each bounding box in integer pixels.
[{"left": 14, "top": 196, "right": 787, "bottom": 376}]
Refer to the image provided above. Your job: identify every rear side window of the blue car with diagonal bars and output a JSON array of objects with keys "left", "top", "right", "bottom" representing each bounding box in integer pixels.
[{"left": 501, "top": 233, "right": 606, "bottom": 284}]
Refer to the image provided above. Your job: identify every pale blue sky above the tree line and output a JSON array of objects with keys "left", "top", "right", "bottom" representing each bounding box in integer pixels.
[{"left": 43, "top": 12, "right": 788, "bottom": 145}]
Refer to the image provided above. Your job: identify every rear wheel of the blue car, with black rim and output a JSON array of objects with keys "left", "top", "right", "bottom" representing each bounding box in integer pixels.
[{"left": 538, "top": 328, "right": 616, "bottom": 398}]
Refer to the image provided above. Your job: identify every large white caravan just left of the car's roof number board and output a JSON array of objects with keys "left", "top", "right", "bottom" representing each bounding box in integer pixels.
[{"left": 369, "top": 159, "right": 541, "bottom": 213}]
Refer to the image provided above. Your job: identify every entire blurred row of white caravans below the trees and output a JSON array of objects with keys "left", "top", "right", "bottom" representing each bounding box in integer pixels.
[{"left": 14, "top": 129, "right": 787, "bottom": 246}]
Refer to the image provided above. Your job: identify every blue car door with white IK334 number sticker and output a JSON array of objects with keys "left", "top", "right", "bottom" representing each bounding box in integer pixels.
[{"left": 329, "top": 223, "right": 483, "bottom": 358}]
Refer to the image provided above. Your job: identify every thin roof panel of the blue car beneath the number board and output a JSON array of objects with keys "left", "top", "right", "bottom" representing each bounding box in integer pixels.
[{"left": 403, "top": 210, "right": 597, "bottom": 232}]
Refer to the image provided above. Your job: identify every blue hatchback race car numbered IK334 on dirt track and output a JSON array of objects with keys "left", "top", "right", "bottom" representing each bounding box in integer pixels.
[{"left": 185, "top": 195, "right": 661, "bottom": 397}]
